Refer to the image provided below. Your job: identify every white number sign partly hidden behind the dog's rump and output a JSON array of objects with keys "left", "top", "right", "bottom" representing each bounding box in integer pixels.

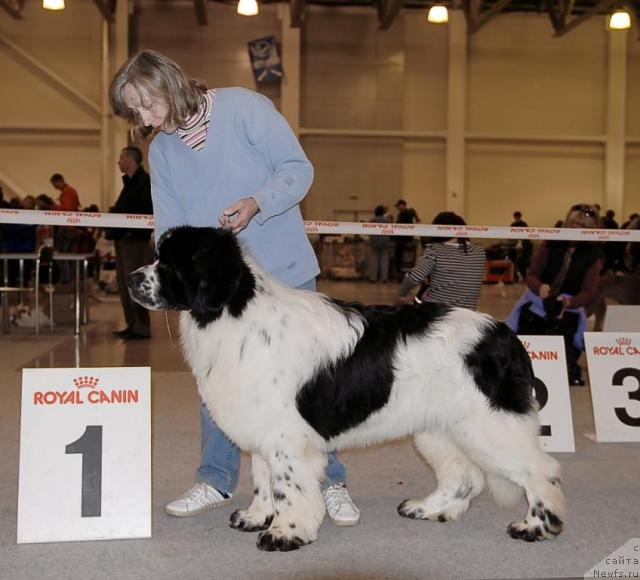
[{"left": 519, "top": 336, "right": 576, "bottom": 452}]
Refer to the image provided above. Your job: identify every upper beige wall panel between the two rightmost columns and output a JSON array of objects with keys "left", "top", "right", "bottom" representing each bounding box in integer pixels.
[{"left": 467, "top": 14, "right": 607, "bottom": 135}]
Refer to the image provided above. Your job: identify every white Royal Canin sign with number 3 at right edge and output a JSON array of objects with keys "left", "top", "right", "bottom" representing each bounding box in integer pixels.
[{"left": 585, "top": 332, "right": 640, "bottom": 443}]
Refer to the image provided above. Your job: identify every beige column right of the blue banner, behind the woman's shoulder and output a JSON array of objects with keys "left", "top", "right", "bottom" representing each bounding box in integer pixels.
[{"left": 279, "top": 3, "right": 300, "bottom": 135}]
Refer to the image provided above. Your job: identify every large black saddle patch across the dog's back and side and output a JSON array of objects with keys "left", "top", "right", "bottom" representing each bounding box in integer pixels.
[{"left": 296, "top": 301, "right": 450, "bottom": 439}]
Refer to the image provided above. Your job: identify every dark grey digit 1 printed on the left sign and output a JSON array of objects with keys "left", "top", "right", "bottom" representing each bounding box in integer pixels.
[{"left": 65, "top": 425, "right": 102, "bottom": 518}]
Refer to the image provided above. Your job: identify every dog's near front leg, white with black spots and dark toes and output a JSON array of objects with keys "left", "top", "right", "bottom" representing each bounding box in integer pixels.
[{"left": 257, "top": 432, "right": 327, "bottom": 552}]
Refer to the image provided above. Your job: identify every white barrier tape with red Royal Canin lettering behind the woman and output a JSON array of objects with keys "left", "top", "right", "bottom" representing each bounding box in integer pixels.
[{"left": 0, "top": 209, "right": 640, "bottom": 242}]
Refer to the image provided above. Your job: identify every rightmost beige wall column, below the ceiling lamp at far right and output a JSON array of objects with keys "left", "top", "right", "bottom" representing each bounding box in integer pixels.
[{"left": 602, "top": 30, "right": 629, "bottom": 218}]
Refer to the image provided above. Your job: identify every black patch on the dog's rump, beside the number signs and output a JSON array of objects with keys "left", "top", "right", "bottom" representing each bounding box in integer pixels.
[{"left": 464, "top": 322, "right": 534, "bottom": 413}]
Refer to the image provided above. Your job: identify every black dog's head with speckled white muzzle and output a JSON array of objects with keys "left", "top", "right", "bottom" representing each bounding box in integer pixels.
[{"left": 128, "top": 226, "right": 255, "bottom": 326}]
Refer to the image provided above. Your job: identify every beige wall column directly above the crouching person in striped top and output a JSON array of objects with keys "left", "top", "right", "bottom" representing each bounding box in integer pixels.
[{"left": 446, "top": 10, "right": 467, "bottom": 215}]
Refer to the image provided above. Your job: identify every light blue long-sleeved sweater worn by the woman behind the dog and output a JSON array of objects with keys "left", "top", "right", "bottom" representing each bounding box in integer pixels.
[{"left": 149, "top": 88, "right": 319, "bottom": 286}]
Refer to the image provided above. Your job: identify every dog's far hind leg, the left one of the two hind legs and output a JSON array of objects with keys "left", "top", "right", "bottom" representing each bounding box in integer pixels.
[{"left": 398, "top": 432, "right": 484, "bottom": 522}]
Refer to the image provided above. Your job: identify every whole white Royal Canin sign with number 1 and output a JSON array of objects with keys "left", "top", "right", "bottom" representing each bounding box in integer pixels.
[{"left": 18, "top": 367, "right": 151, "bottom": 543}]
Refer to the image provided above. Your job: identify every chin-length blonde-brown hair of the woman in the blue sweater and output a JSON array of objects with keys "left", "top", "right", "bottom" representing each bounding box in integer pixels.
[{"left": 109, "top": 50, "right": 207, "bottom": 136}]
